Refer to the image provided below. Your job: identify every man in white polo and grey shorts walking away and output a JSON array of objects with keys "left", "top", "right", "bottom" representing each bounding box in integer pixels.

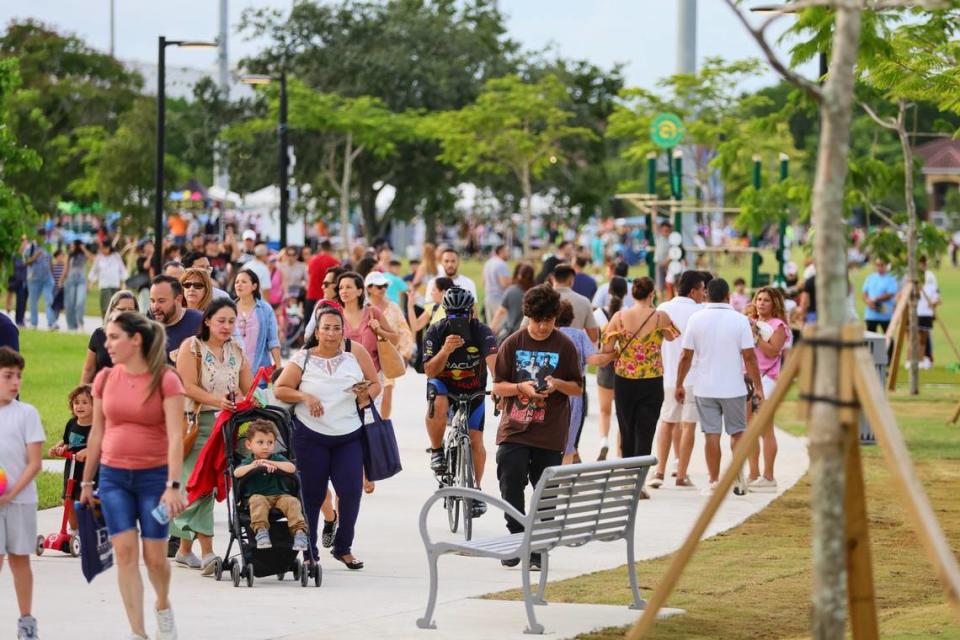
[{"left": 674, "top": 278, "right": 763, "bottom": 495}]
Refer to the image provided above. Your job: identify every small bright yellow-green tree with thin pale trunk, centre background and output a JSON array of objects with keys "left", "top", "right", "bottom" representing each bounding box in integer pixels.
[{"left": 424, "top": 75, "right": 593, "bottom": 253}]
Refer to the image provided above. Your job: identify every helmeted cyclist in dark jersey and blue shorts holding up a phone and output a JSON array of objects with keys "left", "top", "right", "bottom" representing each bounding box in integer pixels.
[{"left": 423, "top": 287, "right": 497, "bottom": 517}]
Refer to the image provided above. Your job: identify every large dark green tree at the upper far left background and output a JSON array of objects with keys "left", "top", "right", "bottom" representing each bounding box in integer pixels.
[{"left": 0, "top": 20, "right": 142, "bottom": 211}]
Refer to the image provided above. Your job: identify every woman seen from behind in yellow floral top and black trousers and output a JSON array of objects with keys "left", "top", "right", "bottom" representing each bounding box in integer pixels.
[{"left": 603, "top": 278, "right": 680, "bottom": 458}]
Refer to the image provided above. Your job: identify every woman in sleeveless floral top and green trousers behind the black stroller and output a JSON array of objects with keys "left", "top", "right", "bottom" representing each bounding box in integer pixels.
[{"left": 170, "top": 298, "right": 253, "bottom": 575}]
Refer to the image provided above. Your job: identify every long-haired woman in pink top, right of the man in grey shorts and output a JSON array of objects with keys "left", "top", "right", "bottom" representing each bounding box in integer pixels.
[{"left": 749, "top": 287, "right": 791, "bottom": 491}]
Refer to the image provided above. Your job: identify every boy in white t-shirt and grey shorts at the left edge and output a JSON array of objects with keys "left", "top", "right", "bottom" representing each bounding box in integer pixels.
[{"left": 0, "top": 347, "right": 46, "bottom": 640}]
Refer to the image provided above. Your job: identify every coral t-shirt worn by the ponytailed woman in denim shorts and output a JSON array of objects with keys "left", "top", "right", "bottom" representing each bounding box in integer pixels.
[{"left": 93, "top": 366, "right": 183, "bottom": 469}]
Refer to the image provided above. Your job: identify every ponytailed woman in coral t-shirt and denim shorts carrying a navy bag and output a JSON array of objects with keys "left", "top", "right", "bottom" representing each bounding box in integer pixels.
[{"left": 80, "top": 311, "right": 184, "bottom": 640}]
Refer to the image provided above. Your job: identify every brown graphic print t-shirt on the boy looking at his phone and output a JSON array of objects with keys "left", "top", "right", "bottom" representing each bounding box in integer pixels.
[{"left": 494, "top": 330, "right": 583, "bottom": 451}]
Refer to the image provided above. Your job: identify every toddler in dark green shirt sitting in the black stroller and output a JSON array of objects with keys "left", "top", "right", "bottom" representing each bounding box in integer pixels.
[{"left": 233, "top": 420, "right": 308, "bottom": 551}]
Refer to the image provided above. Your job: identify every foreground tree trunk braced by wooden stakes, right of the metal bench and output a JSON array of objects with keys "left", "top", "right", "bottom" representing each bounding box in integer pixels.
[{"left": 808, "top": 0, "right": 862, "bottom": 640}]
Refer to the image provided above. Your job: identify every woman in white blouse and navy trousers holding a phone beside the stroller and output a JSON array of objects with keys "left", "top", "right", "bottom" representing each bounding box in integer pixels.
[{"left": 275, "top": 305, "right": 380, "bottom": 569}]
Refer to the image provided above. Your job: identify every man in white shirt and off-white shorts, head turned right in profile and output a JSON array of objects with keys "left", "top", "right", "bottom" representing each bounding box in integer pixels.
[{"left": 647, "top": 270, "right": 705, "bottom": 489}]
